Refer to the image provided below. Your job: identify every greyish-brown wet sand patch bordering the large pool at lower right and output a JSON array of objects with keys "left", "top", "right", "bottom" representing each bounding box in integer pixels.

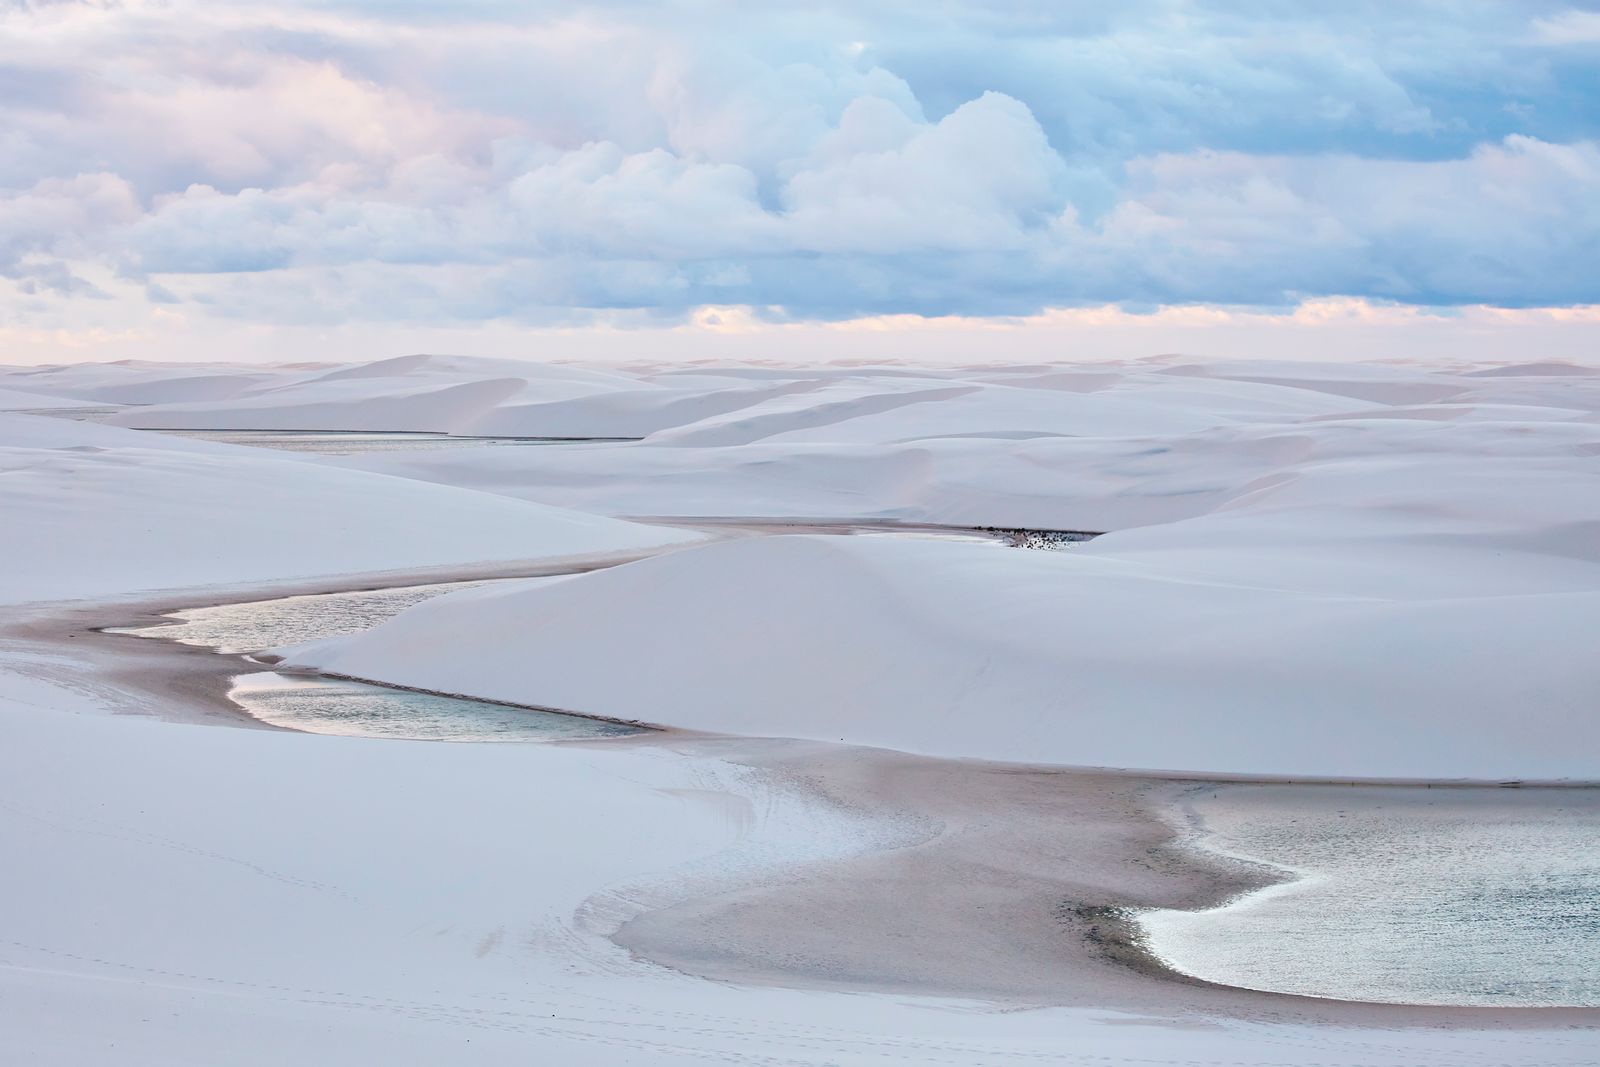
[{"left": 613, "top": 736, "right": 1600, "bottom": 1029}]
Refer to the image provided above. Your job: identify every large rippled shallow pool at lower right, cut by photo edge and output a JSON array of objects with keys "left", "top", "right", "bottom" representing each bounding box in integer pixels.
[{"left": 1139, "top": 785, "right": 1600, "bottom": 1006}]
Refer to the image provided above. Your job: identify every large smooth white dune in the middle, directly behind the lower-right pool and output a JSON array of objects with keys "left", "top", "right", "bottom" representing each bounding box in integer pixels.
[{"left": 291, "top": 528, "right": 1600, "bottom": 779}]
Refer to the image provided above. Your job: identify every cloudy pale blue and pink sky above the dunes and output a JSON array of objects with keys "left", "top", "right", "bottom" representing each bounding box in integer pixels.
[{"left": 0, "top": 0, "right": 1600, "bottom": 363}]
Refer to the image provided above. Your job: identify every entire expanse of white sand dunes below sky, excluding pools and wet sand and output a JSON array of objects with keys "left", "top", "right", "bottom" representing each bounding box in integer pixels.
[{"left": 0, "top": 357, "right": 1600, "bottom": 1067}]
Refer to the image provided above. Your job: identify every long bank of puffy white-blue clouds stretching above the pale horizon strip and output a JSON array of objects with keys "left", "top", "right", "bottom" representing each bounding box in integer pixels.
[{"left": 93, "top": 129, "right": 1600, "bottom": 322}]
